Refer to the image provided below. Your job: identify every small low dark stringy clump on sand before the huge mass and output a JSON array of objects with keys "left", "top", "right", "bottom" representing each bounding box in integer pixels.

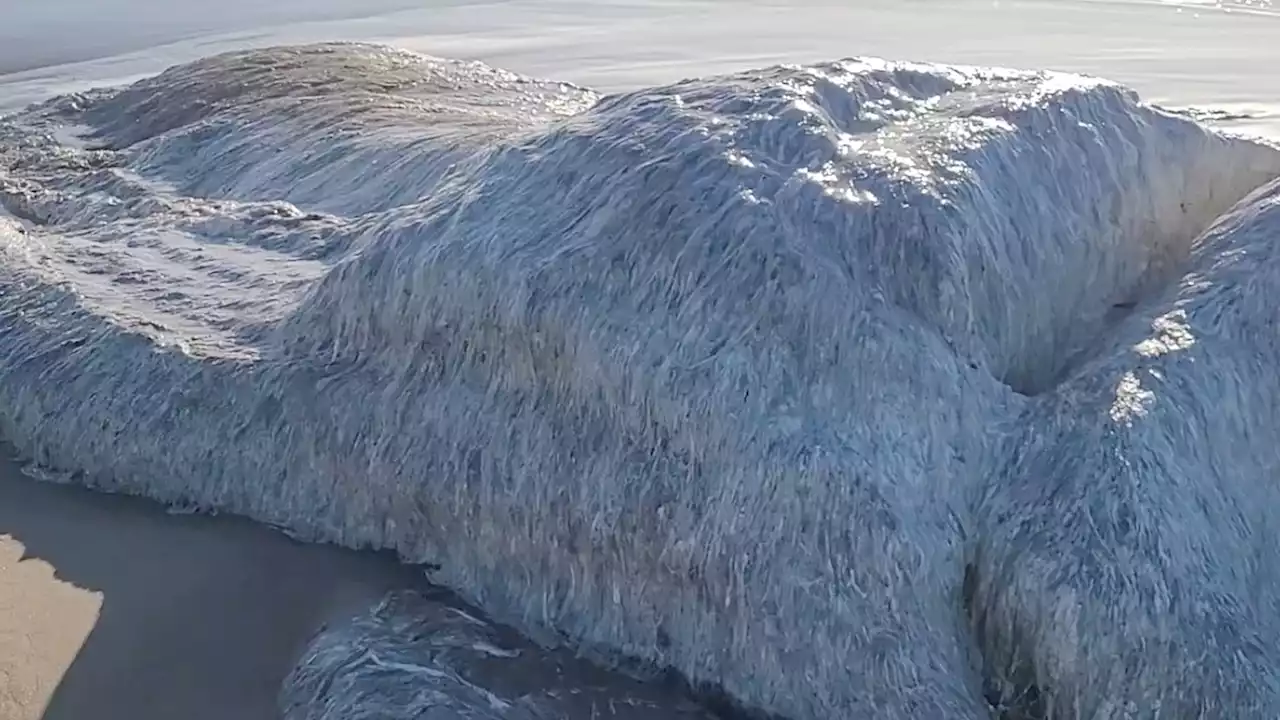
[{"left": 280, "top": 591, "right": 714, "bottom": 720}]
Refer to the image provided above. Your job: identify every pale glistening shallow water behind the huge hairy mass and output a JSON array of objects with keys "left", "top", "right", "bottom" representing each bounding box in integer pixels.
[{"left": 0, "top": 0, "right": 1280, "bottom": 136}]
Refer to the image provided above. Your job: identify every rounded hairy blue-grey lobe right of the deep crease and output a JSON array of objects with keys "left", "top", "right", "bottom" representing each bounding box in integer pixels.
[{"left": 973, "top": 182, "right": 1280, "bottom": 717}]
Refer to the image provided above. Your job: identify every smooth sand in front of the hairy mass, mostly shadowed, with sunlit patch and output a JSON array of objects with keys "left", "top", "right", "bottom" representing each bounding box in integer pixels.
[{"left": 0, "top": 452, "right": 425, "bottom": 720}]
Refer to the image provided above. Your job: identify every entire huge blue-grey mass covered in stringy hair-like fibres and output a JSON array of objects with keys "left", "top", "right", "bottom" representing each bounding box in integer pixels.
[{"left": 0, "top": 45, "right": 1280, "bottom": 720}]
